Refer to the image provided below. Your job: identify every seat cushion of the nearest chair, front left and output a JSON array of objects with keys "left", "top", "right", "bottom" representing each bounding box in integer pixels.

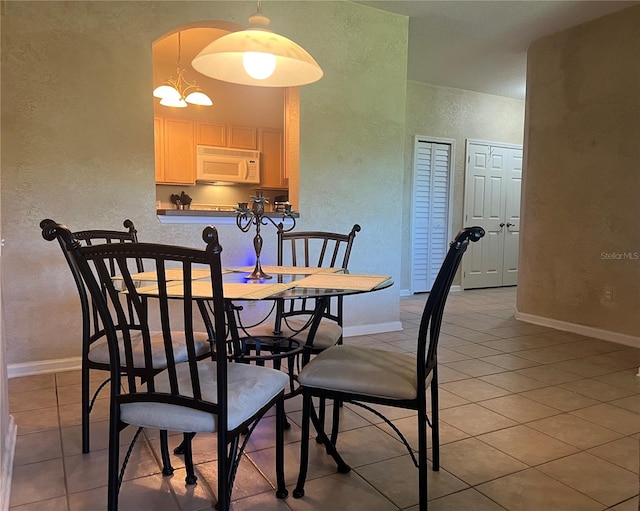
[{"left": 120, "top": 360, "right": 289, "bottom": 433}]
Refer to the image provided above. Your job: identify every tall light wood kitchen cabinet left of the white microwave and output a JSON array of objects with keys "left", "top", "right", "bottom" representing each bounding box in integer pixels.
[{"left": 154, "top": 117, "right": 196, "bottom": 185}]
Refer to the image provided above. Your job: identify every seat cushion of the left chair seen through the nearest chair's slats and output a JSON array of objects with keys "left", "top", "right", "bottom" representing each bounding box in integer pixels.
[{"left": 89, "top": 332, "right": 211, "bottom": 369}]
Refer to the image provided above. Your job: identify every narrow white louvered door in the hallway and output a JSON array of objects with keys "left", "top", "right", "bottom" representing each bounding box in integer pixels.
[{"left": 411, "top": 137, "right": 453, "bottom": 293}]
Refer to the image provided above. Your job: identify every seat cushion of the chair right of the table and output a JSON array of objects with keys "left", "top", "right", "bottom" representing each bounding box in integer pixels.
[{"left": 298, "top": 345, "right": 432, "bottom": 399}]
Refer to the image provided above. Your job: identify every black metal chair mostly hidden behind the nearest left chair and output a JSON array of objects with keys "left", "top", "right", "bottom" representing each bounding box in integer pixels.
[{"left": 40, "top": 219, "right": 211, "bottom": 462}]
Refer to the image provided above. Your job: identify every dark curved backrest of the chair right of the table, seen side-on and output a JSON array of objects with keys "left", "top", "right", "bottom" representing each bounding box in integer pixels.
[{"left": 417, "top": 227, "right": 485, "bottom": 384}]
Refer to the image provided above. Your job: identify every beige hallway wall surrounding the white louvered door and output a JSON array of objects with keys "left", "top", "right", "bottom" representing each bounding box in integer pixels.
[{"left": 400, "top": 82, "right": 524, "bottom": 290}]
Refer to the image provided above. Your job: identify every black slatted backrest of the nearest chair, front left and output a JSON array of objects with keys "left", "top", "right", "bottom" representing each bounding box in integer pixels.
[{"left": 42, "top": 223, "right": 227, "bottom": 424}]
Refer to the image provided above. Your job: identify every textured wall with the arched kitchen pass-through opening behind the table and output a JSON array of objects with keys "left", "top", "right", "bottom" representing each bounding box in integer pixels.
[{"left": 1, "top": 1, "right": 408, "bottom": 364}]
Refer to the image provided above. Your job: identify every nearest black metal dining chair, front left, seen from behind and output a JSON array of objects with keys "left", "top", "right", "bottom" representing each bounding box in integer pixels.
[{"left": 43, "top": 224, "right": 288, "bottom": 511}]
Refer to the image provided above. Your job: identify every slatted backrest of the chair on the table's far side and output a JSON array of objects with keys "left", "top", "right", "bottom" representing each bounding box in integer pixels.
[{"left": 276, "top": 224, "right": 361, "bottom": 329}]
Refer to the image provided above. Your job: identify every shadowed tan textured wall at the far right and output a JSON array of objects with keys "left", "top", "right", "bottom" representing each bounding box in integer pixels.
[{"left": 517, "top": 7, "right": 640, "bottom": 336}]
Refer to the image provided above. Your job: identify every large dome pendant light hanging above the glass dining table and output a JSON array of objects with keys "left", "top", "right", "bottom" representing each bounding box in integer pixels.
[{"left": 191, "top": 1, "right": 323, "bottom": 87}]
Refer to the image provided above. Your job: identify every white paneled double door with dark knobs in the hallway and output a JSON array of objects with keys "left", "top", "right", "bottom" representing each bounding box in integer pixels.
[{"left": 462, "top": 140, "right": 522, "bottom": 289}]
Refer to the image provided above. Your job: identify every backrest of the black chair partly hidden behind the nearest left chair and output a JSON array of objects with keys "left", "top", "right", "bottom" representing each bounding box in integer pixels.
[{"left": 40, "top": 218, "right": 144, "bottom": 364}]
